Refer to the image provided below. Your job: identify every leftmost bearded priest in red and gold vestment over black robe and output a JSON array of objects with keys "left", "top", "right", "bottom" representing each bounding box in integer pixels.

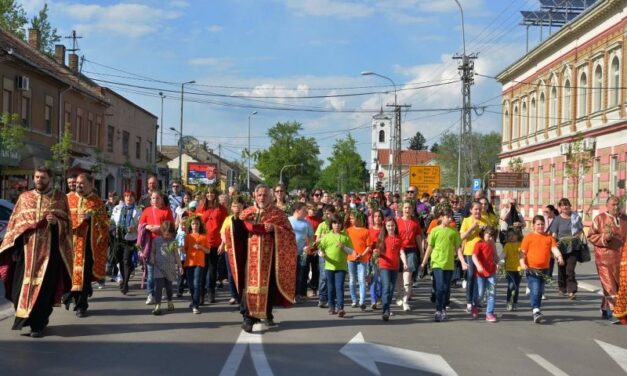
[{"left": 0, "top": 167, "right": 72, "bottom": 338}]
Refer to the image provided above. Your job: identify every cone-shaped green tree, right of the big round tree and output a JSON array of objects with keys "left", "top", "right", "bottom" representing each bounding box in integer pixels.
[{"left": 319, "top": 134, "right": 368, "bottom": 193}]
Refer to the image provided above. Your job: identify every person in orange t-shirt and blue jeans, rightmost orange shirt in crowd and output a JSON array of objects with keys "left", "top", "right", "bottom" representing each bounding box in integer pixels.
[{"left": 520, "top": 215, "right": 564, "bottom": 324}]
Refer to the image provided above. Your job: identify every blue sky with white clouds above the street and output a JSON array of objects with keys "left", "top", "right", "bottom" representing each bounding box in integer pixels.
[{"left": 22, "top": 0, "right": 546, "bottom": 165}]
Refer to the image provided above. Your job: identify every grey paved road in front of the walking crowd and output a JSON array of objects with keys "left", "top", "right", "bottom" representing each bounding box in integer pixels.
[{"left": 0, "top": 263, "right": 627, "bottom": 376}]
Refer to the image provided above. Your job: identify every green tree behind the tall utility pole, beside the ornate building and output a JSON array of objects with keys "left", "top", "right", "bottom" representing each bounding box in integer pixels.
[{"left": 436, "top": 132, "right": 501, "bottom": 187}]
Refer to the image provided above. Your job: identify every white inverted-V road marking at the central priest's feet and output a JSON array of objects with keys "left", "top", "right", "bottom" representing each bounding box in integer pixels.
[{"left": 220, "top": 330, "right": 273, "bottom": 376}]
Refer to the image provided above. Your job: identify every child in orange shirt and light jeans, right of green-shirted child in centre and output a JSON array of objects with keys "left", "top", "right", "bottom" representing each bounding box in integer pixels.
[{"left": 345, "top": 210, "right": 372, "bottom": 311}]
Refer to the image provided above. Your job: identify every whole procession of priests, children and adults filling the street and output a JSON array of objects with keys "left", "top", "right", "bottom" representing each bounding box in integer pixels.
[{"left": 0, "top": 167, "right": 627, "bottom": 338}]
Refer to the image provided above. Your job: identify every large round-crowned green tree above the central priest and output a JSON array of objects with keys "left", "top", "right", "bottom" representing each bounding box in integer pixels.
[{"left": 253, "top": 122, "right": 322, "bottom": 189}]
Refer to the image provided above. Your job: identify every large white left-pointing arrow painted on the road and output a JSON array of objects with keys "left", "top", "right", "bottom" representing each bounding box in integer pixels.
[{"left": 340, "top": 332, "right": 457, "bottom": 376}]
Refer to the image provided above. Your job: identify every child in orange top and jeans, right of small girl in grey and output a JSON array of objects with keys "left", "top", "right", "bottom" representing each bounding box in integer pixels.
[{"left": 185, "top": 216, "right": 211, "bottom": 315}]
